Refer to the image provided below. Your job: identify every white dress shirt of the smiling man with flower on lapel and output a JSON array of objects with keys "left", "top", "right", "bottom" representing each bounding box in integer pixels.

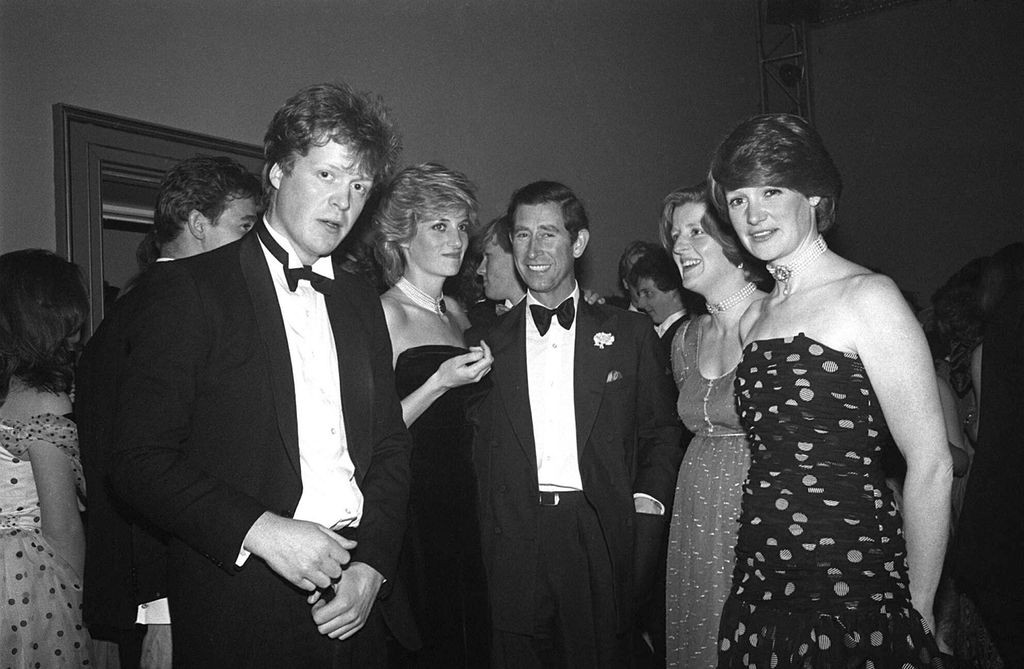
[{"left": 524, "top": 285, "right": 583, "bottom": 492}]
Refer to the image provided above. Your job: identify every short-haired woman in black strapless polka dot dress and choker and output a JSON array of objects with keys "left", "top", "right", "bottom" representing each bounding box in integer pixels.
[{"left": 710, "top": 115, "right": 951, "bottom": 669}]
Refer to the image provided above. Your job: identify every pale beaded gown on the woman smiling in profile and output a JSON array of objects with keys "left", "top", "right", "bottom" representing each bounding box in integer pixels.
[{"left": 666, "top": 316, "right": 751, "bottom": 669}]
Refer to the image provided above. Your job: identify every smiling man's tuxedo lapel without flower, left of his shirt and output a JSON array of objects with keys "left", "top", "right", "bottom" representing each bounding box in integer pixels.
[{"left": 487, "top": 299, "right": 537, "bottom": 463}]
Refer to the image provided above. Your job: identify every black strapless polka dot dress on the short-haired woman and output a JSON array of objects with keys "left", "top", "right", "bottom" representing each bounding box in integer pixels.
[{"left": 719, "top": 334, "right": 942, "bottom": 669}]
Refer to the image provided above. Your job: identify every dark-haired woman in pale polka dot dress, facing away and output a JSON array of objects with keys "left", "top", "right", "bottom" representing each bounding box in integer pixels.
[{"left": 0, "top": 250, "right": 90, "bottom": 669}]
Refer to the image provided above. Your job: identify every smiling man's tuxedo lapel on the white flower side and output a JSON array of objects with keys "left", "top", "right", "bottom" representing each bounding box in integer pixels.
[{"left": 572, "top": 300, "right": 611, "bottom": 455}]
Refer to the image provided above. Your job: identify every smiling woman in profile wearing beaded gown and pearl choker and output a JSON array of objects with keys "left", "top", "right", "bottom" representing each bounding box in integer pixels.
[{"left": 662, "top": 183, "right": 765, "bottom": 669}]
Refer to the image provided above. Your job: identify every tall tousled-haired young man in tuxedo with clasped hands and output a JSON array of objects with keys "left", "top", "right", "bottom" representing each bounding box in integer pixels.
[{"left": 111, "top": 84, "right": 415, "bottom": 668}]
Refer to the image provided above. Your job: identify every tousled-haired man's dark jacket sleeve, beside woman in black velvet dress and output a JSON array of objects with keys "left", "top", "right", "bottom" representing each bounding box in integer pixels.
[{"left": 342, "top": 278, "right": 412, "bottom": 594}]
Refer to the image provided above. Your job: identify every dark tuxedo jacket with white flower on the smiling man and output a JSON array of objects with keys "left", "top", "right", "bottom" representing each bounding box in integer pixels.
[{"left": 468, "top": 300, "right": 682, "bottom": 634}]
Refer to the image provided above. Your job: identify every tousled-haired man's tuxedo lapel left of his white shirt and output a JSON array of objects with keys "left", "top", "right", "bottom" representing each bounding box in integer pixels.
[{"left": 239, "top": 235, "right": 301, "bottom": 475}]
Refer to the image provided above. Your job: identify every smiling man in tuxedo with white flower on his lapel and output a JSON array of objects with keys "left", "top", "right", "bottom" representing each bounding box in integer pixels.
[{"left": 471, "top": 181, "right": 682, "bottom": 669}]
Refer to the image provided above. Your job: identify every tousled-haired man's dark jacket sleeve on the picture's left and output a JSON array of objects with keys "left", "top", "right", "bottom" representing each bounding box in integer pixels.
[{"left": 110, "top": 261, "right": 266, "bottom": 569}]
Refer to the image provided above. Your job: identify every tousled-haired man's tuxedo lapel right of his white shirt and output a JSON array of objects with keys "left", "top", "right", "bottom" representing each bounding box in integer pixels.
[{"left": 325, "top": 274, "right": 374, "bottom": 475}]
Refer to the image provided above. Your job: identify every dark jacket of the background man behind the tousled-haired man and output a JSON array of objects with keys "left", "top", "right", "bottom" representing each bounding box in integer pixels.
[{"left": 75, "top": 262, "right": 174, "bottom": 640}]
